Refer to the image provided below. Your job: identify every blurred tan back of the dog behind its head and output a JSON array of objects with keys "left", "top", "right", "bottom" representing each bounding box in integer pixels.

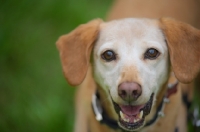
[{"left": 107, "top": 0, "right": 200, "bottom": 28}]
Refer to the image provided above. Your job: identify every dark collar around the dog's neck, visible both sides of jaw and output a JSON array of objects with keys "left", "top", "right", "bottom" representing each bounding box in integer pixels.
[{"left": 92, "top": 82, "right": 178, "bottom": 129}]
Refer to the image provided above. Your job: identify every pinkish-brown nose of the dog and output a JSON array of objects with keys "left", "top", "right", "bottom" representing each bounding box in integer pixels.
[{"left": 118, "top": 82, "right": 142, "bottom": 102}]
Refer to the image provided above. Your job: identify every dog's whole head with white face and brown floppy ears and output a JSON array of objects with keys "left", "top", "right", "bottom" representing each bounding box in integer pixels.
[{"left": 57, "top": 18, "right": 200, "bottom": 131}]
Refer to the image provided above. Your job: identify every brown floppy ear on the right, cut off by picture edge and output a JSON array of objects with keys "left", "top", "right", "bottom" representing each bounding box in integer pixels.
[{"left": 160, "top": 18, "right": 200, "bottom": 83}]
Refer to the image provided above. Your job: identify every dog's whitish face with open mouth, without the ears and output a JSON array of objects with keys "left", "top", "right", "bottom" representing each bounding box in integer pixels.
[{"left": 93, "top": 19, "right": 169, "bottom": 130}]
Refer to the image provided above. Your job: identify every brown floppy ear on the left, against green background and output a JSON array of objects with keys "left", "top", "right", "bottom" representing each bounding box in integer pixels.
[{"left": 56, "top": 19, "right": 102, "bottom": 86}]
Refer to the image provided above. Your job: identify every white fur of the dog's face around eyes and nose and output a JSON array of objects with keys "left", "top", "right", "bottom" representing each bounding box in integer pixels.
[{"left": 93, "top": 18, "right": 169, "bottom": 105}]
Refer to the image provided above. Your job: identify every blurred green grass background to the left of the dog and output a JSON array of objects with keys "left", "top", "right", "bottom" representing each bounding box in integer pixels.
[{"left": 0, "top": 0, "right": 112, "bottom": 132}]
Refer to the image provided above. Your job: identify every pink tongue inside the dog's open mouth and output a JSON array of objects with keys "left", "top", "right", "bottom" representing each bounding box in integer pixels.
[{"left": 120, "top": 105, "right": 144, "bottom": 116}]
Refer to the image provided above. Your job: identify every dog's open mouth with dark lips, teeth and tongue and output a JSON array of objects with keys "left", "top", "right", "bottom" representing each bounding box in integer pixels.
[{"left": 113, "top": 93, "right": 154, "bottom": 131}]
